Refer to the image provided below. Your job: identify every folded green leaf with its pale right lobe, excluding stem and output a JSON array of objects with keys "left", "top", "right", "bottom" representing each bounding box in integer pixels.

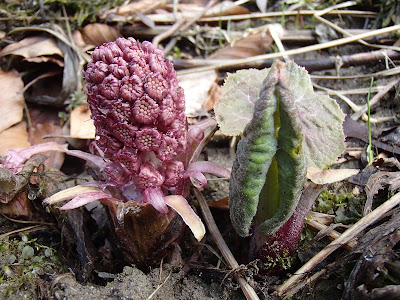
[{"left": 227, "top": 61, "right": 344, "bottom": 236}]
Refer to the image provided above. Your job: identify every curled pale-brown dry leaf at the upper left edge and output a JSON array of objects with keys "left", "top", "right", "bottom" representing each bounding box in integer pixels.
[{"left": 0, "top": 36, "right": 64, "bottom": 67}]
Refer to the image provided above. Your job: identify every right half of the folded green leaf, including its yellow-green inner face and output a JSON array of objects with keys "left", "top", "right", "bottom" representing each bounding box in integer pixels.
[{"left": 256, "top": 63, "right": 307, "bottom": 235}]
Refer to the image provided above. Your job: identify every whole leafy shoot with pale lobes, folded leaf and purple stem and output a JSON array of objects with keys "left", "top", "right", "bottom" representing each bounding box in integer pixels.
[{"left": 215, "top": 61, "right": 344, "bottom": 272}]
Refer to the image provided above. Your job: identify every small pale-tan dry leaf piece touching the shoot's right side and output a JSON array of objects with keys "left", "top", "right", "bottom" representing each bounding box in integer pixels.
[{"left": 307, "top": 167, "right": 360, "bottom": 184}]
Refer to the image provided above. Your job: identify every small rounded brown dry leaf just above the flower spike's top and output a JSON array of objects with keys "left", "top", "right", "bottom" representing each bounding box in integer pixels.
[{"left": 80, "top": 23, "right": 121, "bottom": 46}]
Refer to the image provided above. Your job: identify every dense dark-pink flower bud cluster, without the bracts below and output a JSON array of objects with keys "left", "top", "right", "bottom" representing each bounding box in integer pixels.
[{"left": 85, "top": 38, "right": 187, "bottom": 190}]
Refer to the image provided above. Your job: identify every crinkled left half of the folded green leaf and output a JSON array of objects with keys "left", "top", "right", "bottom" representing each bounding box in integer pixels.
[{"left": 229, "top": 68, "right": 278, "bottom": 236}]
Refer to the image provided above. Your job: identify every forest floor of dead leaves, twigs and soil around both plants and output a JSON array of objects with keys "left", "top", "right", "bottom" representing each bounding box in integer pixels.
[{"left": 0, "top": 0, "right": 400, "bottom": 300}]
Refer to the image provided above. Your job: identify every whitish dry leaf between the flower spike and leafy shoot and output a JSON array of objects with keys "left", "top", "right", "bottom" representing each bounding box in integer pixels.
[{"left": 178, "top": 70, "right": 218, "bottom": 117}]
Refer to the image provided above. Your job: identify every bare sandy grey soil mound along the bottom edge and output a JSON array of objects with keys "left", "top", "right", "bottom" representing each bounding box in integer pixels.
[{"left": 52, "top": 266, "right": 244, "bottom": 300}]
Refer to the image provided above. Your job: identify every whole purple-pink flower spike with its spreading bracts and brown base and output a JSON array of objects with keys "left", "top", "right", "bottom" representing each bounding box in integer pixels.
[{"left": 41, "top": 38, "right": 231, "bottom": 251}]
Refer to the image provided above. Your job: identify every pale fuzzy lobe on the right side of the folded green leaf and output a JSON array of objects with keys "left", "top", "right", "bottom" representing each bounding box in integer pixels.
[{"left": 281, "top": 63, "right": 345, "bottom": 169}]
